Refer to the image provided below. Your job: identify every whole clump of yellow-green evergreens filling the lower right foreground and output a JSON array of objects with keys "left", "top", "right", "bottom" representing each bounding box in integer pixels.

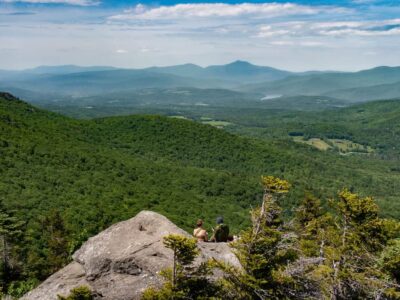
[{"left": 214, "top": 178, "right": 400, "bottom": 299}]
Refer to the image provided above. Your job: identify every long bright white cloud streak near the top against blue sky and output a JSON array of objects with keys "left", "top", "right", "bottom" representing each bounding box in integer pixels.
[{"left": 110, "top": 3, "right": 322, "bottom": 20}]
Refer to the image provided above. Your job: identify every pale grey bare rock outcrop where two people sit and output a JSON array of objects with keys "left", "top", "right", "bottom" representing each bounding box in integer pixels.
[{"left": 22, "top": 211, "right": 240, "bottom": 300}]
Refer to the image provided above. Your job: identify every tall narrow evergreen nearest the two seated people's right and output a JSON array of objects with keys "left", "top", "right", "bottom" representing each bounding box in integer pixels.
[{"left": 216, "top": 176, "right": 297, "bottom": 299}]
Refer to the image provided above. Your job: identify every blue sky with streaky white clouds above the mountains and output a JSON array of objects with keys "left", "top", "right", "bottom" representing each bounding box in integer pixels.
[{"left": 0, "top": 0, "right": 400, "bottom": 71}]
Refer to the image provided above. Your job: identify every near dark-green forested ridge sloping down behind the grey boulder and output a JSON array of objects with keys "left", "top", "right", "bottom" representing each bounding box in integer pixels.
[{"left": 0, "top": 94, "right": 400, "bottom": 295}]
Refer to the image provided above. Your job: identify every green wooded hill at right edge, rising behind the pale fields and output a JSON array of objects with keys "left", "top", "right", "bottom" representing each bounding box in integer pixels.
[{"left": 236, "top": 99, "right": 400, "bottom": 158}]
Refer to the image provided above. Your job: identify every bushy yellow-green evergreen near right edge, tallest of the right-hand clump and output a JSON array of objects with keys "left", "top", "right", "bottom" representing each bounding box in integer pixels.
[{"left": 331, "top": 190, "right": 396, "bottom": 299}]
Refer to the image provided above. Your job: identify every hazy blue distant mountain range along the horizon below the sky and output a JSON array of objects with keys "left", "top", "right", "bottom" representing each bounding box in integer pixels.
[{"left": 0, "top": 61, "right": 400, "bottom": 107}]
